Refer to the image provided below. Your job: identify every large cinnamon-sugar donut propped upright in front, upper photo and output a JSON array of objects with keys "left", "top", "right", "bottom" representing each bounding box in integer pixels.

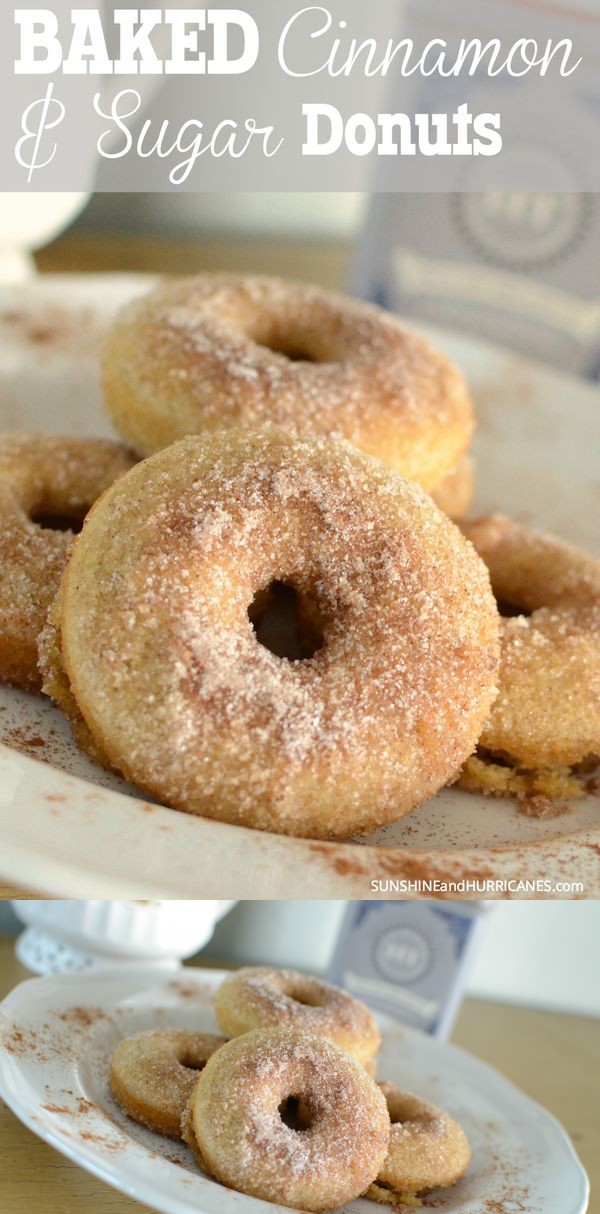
[{"left": 46, "top": 429, "right": 498, "bottom": 838}]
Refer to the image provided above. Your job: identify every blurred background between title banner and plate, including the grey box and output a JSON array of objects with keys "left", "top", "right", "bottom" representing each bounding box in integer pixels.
[{"left": 11, "top": 192, "right": 600, "bottom": 382}]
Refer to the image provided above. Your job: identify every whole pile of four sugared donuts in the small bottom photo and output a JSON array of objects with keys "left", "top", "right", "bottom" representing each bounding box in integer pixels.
[{"left": 111, "top": 968, "right": 470, "bottom": 1210}]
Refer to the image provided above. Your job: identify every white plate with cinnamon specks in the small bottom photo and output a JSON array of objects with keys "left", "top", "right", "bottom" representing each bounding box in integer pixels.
[{"left": 0, "top": 969, "right": 588, "bottom": 1214}]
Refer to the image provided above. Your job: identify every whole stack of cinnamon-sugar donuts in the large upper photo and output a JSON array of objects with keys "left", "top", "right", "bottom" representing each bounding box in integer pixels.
[{"left": 0, "top": 274, "right": 600, "bottom": 839}]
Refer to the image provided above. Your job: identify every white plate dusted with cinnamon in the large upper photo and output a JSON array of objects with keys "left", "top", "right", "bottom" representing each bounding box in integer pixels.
[{"left": 0, "top": 276, "right": 600, "bottom": 898}]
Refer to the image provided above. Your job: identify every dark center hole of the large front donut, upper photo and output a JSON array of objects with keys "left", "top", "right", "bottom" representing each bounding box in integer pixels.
[{"left": 248, "top": 582, "right": 324, "bottom": 662}]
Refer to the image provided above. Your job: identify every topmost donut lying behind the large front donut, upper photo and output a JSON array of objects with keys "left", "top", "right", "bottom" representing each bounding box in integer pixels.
[{"left": 103, "top": 274, "right": 474, "bottom": 489}]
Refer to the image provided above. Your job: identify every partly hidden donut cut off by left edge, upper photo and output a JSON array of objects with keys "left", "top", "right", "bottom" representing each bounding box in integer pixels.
[{"left": 0, "top": 433, "right": 135, "bottom": 691}]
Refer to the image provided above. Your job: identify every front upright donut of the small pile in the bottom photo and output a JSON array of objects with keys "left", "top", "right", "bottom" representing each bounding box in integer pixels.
[{"left": 182, "top": 1028, "right": 390, "bottom": 1210}]
